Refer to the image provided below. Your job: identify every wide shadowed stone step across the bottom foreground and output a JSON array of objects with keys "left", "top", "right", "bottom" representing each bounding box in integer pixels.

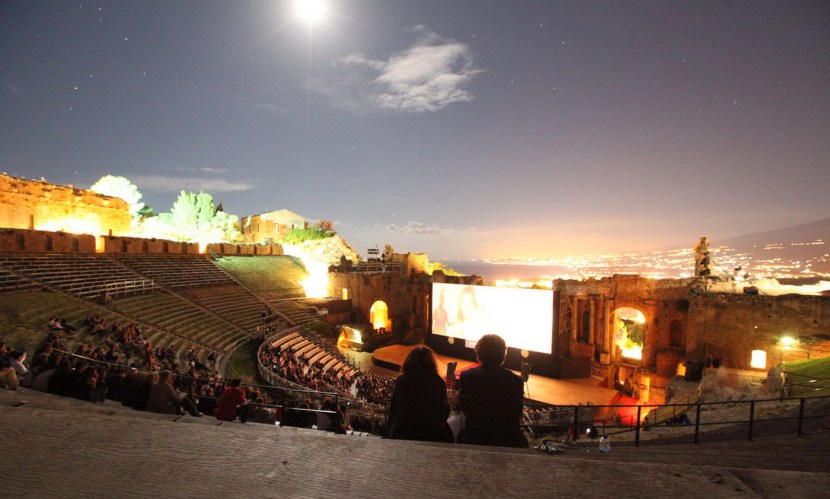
[{"left": 0, "top": 389, "right": 830, "bottom": 497}]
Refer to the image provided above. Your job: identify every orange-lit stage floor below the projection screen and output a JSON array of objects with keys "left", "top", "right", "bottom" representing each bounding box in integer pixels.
[{"left": 372, "top": 345, "right": 619, "bottom": 405}]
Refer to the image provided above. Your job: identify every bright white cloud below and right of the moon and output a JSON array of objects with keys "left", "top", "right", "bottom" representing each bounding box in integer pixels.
[{"left": 310, "top": 26, "right": 481, "bottom": 113}]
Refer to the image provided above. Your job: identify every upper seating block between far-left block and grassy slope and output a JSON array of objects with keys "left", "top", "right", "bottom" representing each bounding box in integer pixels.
[{"left": 118, "top": 254, "right": 234, "bottom": 288}]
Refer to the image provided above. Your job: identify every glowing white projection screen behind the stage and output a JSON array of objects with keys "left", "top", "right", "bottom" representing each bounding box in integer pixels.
[{"left": 432, "top": 283, "right": 553, "bottom": 354}]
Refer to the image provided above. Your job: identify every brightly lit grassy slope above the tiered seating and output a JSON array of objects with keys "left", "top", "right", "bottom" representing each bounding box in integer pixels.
[{"left": 216, "top": 256, "right": 308, "bottom": 296}]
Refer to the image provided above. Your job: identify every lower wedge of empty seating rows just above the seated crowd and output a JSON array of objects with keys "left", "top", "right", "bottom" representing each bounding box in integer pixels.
[{"left": 112, "top": 293, "right": 248, "bottom": 352}]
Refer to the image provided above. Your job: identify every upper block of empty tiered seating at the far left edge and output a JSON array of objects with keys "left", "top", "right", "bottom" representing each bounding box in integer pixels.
[{"left": 0, "top": 253, "right": 159, "bottom": 299}]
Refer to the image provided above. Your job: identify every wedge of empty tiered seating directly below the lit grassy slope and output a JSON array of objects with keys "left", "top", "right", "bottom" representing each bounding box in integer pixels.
[{"left": 179, "top": 284, "right": 272, "bottom": 331}]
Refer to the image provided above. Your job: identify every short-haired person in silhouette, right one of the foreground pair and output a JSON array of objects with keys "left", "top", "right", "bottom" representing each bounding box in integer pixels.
[{"left": 459, "top": 334, "right": 528, "bottom": 447}]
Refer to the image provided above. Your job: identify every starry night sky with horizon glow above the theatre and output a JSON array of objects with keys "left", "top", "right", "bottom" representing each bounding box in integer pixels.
[{"left": 0, "top": 0, "right": 830, "bottom": 259}]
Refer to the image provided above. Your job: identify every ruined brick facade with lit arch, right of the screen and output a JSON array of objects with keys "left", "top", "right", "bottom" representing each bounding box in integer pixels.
[{"left": 554, "top": 275, "right": 830, "bottom": 402}]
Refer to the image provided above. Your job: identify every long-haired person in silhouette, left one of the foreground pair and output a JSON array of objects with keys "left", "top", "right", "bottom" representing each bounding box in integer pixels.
[{"left": 389, "top": 346, "right": 454, "bottom": 442}]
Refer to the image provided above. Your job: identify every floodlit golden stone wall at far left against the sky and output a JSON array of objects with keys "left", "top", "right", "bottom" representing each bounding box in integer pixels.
[{"left": 0, "top": 173, "right": 131, "bottom": 235}]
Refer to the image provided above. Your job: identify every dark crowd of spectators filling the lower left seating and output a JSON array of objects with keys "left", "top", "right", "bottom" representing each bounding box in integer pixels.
[{"left": 0, "top": 314, "right": 383, "bottom": 433}]
